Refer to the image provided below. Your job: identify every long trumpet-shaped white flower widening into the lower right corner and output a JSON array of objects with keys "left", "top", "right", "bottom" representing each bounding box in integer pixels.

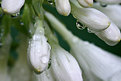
[{"left": 45, "top": 12, "right": 121, "bottom": 81}]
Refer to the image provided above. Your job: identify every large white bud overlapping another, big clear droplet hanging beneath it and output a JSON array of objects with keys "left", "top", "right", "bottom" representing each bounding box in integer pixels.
[{"left": 72, "top": 6, "right": 110, "bottom": 31}]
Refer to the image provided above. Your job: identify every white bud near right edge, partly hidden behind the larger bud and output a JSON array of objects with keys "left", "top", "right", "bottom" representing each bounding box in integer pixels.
[{"left": 95, "top": 23, "right": 121, "bottom": 46}]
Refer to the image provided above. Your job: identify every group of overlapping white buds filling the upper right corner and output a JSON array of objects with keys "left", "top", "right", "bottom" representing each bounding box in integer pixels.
[{"left": 53, "top": 0, "right": 121, "bottom": 46}]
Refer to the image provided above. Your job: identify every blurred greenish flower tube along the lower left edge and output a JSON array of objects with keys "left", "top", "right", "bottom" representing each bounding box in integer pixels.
[{"left": 0, "top": 35, "right": 11, "bottom": 81}]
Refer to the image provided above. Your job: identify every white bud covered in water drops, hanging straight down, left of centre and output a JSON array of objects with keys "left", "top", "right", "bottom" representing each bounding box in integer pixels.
[{"left": 28, "top": 21, "right": 51, "bottom": 72}]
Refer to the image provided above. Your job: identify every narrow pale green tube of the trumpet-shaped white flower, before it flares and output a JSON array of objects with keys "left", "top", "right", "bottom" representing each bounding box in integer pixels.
[{"left": 45, "top": 12, "right": 77, "bottom": 44}]
